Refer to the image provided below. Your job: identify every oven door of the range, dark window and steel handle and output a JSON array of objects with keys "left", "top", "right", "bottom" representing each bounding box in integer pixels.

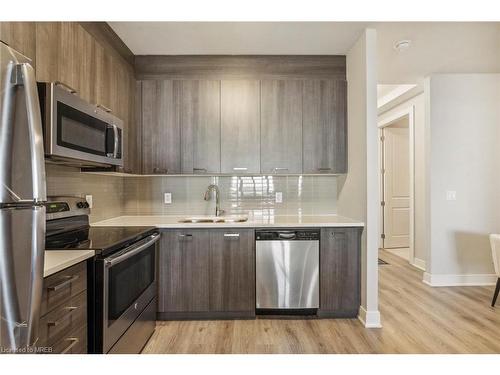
[{"left": 102, "top": 233, "right": 160, "bottom": 353}]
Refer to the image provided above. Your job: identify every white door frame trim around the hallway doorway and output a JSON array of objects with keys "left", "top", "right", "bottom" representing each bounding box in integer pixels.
[{"left": 378, "top": 105, "right": 415, "bottom": 265}]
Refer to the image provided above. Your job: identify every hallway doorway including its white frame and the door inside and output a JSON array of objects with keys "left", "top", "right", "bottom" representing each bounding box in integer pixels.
[{"left": 379, "top": 108, "right": 414, "bottom": 264}]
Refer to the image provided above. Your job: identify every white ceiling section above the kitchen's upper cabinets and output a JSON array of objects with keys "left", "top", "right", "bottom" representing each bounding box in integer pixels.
[{"left": 109, "top": 22, "right": 367, "bottom": 55}]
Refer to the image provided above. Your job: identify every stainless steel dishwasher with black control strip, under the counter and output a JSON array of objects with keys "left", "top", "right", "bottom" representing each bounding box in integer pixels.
[{"left": 255, "top": 229, "right": 320, "bottom": 314}]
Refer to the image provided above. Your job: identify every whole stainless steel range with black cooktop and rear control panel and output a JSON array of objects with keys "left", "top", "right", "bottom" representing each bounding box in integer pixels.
[{"left": 46, "top": 197, "right": 160, "bottom": 353}]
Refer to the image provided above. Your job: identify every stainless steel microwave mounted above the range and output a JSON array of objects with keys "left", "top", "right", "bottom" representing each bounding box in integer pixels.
[{"left": 38, "top": 82, "right": 123, "bottom": 167}]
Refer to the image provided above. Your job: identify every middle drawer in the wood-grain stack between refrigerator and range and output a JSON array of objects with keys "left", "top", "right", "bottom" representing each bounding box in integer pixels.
[{"left": 39, "top": 291, "right": 87, "bottom": 346}]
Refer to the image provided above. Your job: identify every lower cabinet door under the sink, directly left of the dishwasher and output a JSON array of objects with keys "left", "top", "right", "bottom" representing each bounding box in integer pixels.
[{"left": 210, "top": 229, "right": 255, "bottom": 315}]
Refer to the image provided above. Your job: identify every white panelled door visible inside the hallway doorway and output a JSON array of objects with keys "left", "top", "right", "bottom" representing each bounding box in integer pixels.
[{"left": 382, "top": 123, "right": 410, "bottom": 248}]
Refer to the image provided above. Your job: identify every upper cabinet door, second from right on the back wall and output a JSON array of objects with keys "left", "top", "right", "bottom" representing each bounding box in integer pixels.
[{"left": 260, "top": 80, "right": 302, "bottom": 173}]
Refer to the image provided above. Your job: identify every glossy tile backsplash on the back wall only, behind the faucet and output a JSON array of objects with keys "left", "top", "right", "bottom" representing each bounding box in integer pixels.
[{"left": 123, "top": 176, "right": 337, "bottom": 215}]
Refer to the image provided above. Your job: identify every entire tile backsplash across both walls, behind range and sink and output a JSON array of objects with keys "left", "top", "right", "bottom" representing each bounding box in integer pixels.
[{"left": 46, "top": 164, "right": 337, "bottom": 222}]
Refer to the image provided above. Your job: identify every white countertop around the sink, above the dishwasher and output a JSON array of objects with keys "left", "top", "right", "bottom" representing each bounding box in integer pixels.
[{"left": 92, "top": 215, "right": 364, "bottom": 228}]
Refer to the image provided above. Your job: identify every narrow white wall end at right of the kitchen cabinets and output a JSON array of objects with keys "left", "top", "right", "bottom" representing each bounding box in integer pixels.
[{"left": 337, "top": 29, "right": 380, "bottom": 327}]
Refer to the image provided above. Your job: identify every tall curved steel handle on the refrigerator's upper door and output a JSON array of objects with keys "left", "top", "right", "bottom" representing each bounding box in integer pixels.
[{"left": 18, "top": 63, "right": 47, "bottom": 202}]
